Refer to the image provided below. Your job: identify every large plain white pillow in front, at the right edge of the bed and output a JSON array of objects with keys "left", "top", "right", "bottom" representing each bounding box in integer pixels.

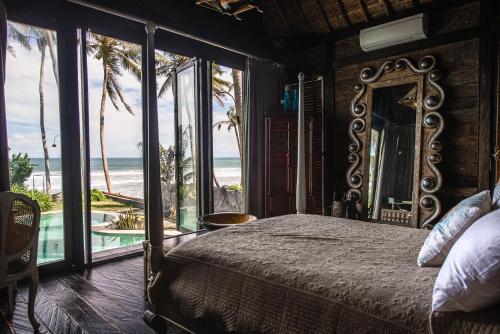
[{"left": 432, "top": 210, "right": 500, "bottom": 312}]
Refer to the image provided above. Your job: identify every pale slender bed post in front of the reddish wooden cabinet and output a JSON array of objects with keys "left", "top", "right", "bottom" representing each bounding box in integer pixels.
[{"left": 295, "top": 72, "right": 306, "bottom": 214}]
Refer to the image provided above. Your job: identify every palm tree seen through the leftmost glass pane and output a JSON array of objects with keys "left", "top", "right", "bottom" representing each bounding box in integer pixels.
[{"left": 8, "top": 23, "right": 59, "bottom": 194}]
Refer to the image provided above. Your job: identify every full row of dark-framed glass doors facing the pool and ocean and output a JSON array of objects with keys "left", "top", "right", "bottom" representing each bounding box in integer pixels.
[{"left": 0, "top": 3, "right": 247, "bottom": 272}]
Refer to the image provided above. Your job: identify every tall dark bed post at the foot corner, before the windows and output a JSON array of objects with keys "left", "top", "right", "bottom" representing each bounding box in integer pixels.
[{"left": 146, "top": 22, "right": 163, "bottom": 273}]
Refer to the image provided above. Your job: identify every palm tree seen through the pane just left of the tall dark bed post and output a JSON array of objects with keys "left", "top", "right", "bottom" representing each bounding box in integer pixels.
[{"left": 87, "top": 33, "right": 141, "bottom": 192}]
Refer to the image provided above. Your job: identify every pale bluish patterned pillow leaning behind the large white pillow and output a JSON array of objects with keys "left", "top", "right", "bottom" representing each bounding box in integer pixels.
[{"left": 417, "top": 190, "right": 491, "bottom": 267}]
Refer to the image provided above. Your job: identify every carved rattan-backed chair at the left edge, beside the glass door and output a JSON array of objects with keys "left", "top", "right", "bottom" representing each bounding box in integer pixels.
[{"left": 0, "top": 192, "right": 40, "bottom": 330}]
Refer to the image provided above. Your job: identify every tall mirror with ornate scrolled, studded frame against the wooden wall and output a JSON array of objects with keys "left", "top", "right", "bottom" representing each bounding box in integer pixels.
[{"left": 347, "top": 56, "right": 444, "bottom": 228}]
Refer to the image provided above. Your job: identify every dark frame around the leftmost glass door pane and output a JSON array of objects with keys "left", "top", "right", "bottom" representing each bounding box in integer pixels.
[{"left": 2, "top": 11, "right": 84, "bottom": 276}]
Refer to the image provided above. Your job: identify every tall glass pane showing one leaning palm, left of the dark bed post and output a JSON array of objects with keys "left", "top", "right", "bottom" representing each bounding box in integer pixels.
[{"left": 87, "top": 33, "right": 145, "bottom": 257}]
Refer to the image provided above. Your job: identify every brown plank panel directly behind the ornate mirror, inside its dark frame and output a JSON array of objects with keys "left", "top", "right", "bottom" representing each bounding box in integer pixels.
[{"left": 329, "top": 39, "right": 482, "bottom": 212}]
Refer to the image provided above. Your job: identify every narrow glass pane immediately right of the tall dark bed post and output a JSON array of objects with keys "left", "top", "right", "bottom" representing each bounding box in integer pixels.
[{"left": 156, "top": 50, "right": 185, "bottom": 236}]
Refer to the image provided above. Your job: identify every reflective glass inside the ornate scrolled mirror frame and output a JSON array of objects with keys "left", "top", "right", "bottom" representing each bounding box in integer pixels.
[{"left": 368, "top": 84, "right": 418, "bottom": 224}]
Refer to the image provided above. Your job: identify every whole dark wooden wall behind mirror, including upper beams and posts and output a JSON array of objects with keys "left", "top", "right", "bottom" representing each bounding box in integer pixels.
[{"left": 283, "top": 1, "right": 500, "bottom": 211}]
